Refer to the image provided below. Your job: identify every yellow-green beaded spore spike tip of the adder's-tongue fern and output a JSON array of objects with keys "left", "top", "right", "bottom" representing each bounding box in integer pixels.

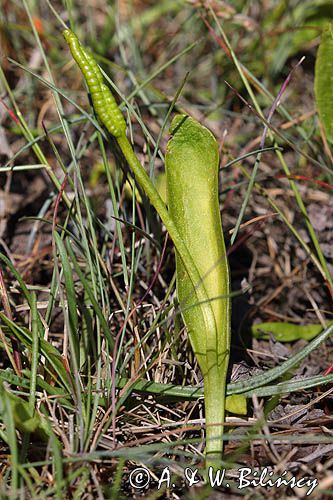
[{"left": 63, "top": 29, "right": 126, "bottom": 137}]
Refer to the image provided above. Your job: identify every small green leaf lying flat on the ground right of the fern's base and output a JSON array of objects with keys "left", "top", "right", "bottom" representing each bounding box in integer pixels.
[{"left": 251, "top": 321, "right": 333, "bottom": 342}]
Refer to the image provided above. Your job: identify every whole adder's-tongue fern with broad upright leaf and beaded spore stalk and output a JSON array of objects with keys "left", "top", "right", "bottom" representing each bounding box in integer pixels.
[{"left": 64, "top": 30, "right": 230, "bottom": 465}]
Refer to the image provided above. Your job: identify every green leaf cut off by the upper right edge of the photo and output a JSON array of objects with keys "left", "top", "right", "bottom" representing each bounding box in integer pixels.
[{"left": 314, "top": 24, "right": 333, "bottom": 141}]
